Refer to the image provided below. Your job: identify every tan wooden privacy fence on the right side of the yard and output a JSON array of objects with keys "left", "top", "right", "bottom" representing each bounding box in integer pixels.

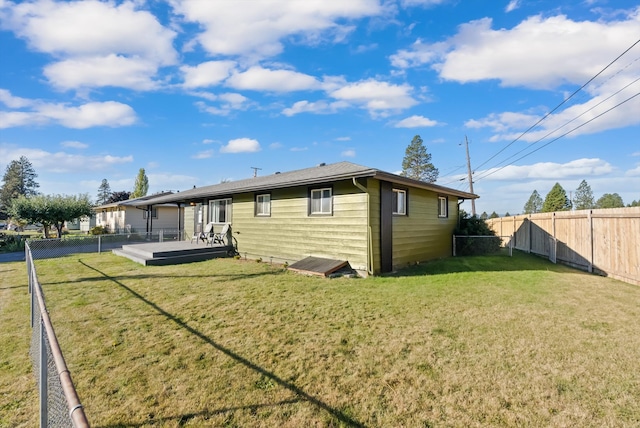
[{"left": 487, "top": 207, "right": 640, "bottom": 285}]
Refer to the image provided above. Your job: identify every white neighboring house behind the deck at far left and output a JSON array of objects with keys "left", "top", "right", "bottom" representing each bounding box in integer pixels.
[{"left": 93, "top": 192, "right": 179, "bottom": 233}]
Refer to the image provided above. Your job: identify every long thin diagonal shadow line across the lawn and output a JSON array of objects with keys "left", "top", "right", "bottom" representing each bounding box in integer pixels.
[{"left": 80, "top": 260, "right": 365, "bottom": 427}]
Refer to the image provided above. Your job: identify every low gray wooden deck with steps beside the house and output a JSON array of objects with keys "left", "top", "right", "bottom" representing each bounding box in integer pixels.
[{"left": 113, "top": 241, "right": 235, "bottom": 266}]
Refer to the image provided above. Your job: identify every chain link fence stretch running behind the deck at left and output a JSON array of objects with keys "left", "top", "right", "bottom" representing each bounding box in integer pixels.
[{"left": 28, "top": 229, "right": 184, "bottom": 260}]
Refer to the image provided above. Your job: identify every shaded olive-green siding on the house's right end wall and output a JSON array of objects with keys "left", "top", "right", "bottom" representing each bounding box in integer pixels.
[{"left": 393, "top": 188, "right": 458, "bottom": 269}]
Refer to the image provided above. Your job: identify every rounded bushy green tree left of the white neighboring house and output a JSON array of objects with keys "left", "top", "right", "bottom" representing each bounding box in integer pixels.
[{"left": 11, "top": 194, "right": 92, "bottom": 238}]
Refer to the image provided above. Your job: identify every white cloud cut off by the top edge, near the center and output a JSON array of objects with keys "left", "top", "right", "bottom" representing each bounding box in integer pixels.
[{"left": 171, "top": 0, "right": 383, "bottom": 59}]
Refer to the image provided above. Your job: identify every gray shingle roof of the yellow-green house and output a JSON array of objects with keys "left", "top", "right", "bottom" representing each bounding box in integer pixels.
[{"left": 142, "top": 162, "right": 478, "bottom": 205}]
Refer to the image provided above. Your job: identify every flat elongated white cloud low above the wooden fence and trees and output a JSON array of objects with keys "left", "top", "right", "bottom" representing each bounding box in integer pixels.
[{"left": 475, "top": 158, "right": 614, "bottom": 181}]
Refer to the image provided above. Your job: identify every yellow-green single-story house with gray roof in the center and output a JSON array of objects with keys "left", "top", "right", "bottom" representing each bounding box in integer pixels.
[{"left": 146, "top": 162, "right": 478, "bottom": 274}]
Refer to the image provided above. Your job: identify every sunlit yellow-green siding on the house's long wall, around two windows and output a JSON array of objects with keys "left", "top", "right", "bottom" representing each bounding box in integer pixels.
[{"left": 232, "top": 181, "right": 368, "bottom": 270}]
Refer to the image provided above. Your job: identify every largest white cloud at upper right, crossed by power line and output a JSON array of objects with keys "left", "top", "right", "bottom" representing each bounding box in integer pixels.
[{"left": 391, "top": 9, "right": 640, "bottom": 88}]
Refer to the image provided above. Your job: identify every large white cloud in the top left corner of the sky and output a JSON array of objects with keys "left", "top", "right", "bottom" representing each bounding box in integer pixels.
[{"left": 0, "top": 0, "right": 177, "bottom": 90}]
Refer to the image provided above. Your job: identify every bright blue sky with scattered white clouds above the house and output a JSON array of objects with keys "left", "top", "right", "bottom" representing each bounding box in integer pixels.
[{"left": 0, "top": 0, "right": 640, "bottom": 214}]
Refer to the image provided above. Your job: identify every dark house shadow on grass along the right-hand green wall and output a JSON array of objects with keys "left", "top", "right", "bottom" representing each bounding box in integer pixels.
[{"left": 384, "top": 251, "right": 581, "bottom": 277}]
